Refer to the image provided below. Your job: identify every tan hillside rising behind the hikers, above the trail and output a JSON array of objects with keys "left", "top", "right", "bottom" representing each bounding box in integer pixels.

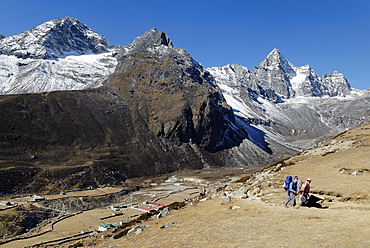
[{"left": 274, "top": 125, "right": 370, "bottom": 203}]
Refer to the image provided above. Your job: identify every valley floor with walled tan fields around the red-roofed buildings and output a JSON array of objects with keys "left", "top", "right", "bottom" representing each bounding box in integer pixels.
[{"left": 0, "top": 167, "right": 256, "bottom": 248}]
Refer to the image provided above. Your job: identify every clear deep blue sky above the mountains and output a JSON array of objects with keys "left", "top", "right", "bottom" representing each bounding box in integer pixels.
[{"left": 0, "top": 0, "right": 370, "bottom": 89}]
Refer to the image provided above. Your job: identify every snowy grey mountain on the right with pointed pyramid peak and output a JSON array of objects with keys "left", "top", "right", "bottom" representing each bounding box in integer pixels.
[{"left": 206, "top": 49, "right": 370, "bottom": 148}]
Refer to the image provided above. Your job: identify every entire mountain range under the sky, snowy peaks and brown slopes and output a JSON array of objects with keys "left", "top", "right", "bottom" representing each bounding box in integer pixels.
[{"left": 0, "top": 17, "right": 370, "bottom": 193}]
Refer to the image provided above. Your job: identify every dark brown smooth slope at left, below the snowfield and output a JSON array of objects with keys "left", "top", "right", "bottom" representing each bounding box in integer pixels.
[{"left": 0, "top": 88, "right": 205, "bottom": 194}]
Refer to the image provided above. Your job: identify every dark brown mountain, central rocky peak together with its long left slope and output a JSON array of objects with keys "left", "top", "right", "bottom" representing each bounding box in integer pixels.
[{"left": 0, "top": 30, "right": 274, "bottom": 196}]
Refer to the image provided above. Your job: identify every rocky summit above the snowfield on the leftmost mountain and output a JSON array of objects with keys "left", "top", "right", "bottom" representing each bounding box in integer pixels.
[{"left": 0, "top": 17, "right": 109, "bottom": 59}]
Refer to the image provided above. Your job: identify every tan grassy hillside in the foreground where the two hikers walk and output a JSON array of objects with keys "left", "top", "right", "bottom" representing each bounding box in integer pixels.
[{"left": 79, "top": 125, "right": 370, "bottom": 247}]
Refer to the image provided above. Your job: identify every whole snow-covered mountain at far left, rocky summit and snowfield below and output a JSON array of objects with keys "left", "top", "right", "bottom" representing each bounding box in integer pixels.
[{"left": 0, "top": 17, "right": 117, "bottom": 94}]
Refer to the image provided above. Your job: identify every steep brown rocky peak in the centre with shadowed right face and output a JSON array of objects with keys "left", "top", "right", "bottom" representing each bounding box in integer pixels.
[{"left": 105, "top": 29, "right": 248, "bottom": 152}]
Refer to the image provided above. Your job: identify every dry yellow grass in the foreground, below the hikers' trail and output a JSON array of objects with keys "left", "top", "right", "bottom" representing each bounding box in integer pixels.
[{"left": 87, "top": 199, "right": 370, "bottom": 247}]
